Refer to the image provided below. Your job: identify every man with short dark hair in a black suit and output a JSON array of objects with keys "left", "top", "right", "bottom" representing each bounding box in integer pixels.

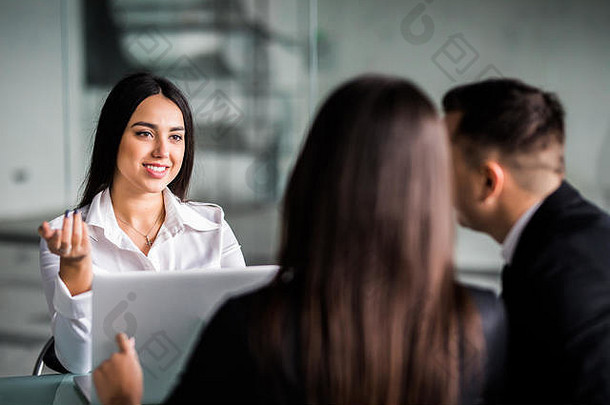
[{"left": 443, "top": 79, "right": 610, "bottom": 404}]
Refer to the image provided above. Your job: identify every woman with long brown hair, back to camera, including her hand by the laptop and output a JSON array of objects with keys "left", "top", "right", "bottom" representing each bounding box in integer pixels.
[{"left": 94, "top": 76, "right": 505, "bottom": 404}]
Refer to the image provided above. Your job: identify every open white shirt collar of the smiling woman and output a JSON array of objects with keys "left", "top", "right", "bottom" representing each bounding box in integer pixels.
[{"left": 86, "top": 188, "right": 220, "bottom": 246}]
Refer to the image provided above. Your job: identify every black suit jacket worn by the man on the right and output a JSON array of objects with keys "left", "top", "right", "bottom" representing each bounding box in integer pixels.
[{"left": 502, "top": 182, "right": 610, "bottom": 404}]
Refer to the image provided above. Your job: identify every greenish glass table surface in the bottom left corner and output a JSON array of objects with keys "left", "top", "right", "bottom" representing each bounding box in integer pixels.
[{"left": 0, "top": 374, "right": 88, "bottom": 405}]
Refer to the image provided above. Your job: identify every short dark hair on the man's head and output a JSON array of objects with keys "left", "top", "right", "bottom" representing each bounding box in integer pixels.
[{"left": 443, "top": 79, "right": 565, "bottom": 155}]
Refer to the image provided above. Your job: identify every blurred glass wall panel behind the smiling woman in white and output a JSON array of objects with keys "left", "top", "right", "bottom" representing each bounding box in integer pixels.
[{"left": 0, "top": 0, "right": 317, "bottom": 258}]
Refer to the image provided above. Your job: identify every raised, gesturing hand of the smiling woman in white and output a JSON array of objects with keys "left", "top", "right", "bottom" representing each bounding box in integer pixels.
[{"left": 38, "top": 211, "right": 93, "bottom": 296}]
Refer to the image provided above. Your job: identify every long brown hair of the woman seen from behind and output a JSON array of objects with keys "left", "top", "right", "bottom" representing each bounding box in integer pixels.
[{"left": 253, "top": 76, "right": 483, "bottom": 404}]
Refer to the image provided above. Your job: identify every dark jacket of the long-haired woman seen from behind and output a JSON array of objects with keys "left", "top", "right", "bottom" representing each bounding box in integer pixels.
[{"left": 166, "top": 280, "right": 507, "bottom": 404}]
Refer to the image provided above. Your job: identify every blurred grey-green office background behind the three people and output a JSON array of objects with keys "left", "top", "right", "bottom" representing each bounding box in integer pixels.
[{"left": 0, "top": 0, "right": 610, "bottom": 376}]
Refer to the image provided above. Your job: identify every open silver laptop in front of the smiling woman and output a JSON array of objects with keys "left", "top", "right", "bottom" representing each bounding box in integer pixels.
[{"left": 74, "top": 266, "right": 278, "bottom": 404}]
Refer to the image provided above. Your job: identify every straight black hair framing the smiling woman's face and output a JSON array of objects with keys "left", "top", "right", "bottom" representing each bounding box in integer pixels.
[{"left": 78, "top": 73, "right": 195, "bottom": 208}]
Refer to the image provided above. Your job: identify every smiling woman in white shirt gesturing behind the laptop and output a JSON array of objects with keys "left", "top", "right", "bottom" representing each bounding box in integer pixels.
[{"left": 39, "top": 73, "right": 245, "bottom": 373}]
